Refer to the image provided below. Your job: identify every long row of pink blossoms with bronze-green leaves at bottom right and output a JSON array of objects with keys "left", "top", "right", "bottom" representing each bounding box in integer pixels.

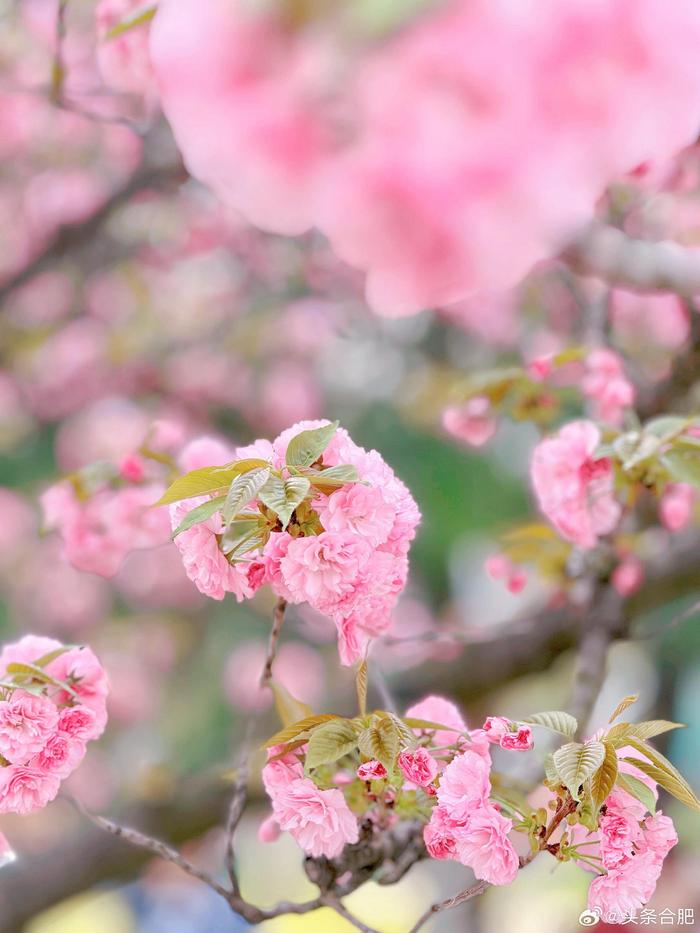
[{"left": 259, "top": 696, "right": 700, "bottom": 915}]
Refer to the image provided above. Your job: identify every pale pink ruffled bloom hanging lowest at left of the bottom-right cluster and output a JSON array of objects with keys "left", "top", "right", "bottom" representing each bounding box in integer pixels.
[{"left": 272, "top": 778, "right": 359, "bottom": 858}]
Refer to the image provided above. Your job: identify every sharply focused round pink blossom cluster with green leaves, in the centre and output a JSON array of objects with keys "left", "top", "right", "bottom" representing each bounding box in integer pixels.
[{"left": 163, "top": 421, "right": 420, "bottom": 664}]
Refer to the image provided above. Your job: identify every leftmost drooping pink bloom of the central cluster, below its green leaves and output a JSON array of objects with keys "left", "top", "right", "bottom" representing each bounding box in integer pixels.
[{"left": 170, "top": 496, "right": 253, "bottom": 602}]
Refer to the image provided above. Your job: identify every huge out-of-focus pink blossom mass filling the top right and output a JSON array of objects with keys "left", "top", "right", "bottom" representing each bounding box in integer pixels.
[{"left": 149, "top": 0, "right": 700, "bottom": 314}]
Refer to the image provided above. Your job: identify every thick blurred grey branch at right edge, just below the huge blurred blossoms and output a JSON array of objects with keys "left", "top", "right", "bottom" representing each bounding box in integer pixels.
[{"left": 561, "top": 223, "right": 700, "bottom": 297}]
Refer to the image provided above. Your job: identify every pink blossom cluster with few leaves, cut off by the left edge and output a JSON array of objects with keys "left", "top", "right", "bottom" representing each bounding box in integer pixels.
[{"left": 0, "top": 635, "right": 108, "bottom": 816}]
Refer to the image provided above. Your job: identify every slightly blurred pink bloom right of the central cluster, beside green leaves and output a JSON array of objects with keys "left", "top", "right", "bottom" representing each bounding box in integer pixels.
[{"left": 531, "top": 421, "right": 622, "bottom": 548}]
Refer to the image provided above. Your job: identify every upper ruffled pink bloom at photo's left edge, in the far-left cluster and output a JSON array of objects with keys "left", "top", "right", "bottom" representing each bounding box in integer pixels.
[{"left": 0, "top": 690, "right": 58, "bottom": 764}]
